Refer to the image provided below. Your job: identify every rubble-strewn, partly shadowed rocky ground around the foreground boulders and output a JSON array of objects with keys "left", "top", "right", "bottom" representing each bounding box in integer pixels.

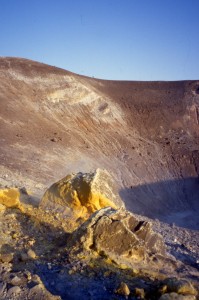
[{"left": 0, "top": 182, "right": 199, "bottom": 300}]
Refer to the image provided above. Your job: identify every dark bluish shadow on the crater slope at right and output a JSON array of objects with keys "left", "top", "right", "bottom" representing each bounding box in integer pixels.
[{"left": 119, "top": 177, "right": 199, "bottom": 229}]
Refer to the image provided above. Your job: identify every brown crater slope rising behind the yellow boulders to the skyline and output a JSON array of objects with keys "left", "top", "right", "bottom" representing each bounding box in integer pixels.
[{"left": 0, "top": 57, "right": 199, "bottom": 229}]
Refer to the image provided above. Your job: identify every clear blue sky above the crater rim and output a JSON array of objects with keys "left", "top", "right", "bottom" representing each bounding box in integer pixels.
[{"left": 0, "top": 0, "right": 199, "bottom": 80}]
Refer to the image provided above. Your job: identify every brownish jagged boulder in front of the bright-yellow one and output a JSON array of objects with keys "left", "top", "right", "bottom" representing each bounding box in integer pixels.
[{"left": 68, "top": 207, "right": 165, "bottom": 266}]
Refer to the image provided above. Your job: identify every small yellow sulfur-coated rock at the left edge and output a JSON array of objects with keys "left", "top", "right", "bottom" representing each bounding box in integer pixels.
[{"left": 0, "top": 188, "right": 20, "bottom": 208}]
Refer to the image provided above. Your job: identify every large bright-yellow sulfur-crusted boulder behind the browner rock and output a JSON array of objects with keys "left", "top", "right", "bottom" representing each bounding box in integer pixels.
[{"left": 40, "top": 169, "right": 124, "bottom": 220}]
